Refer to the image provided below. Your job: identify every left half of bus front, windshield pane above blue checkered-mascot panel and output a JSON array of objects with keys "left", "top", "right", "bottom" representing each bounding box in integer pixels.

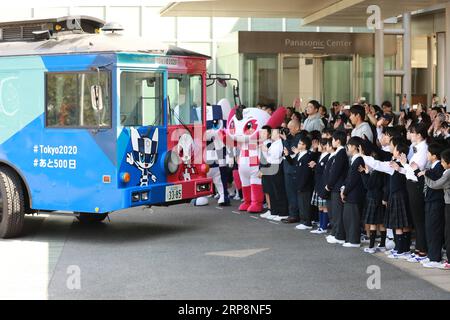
[{"left": 118, "top": 69, "right": 167, "bottom": 190}]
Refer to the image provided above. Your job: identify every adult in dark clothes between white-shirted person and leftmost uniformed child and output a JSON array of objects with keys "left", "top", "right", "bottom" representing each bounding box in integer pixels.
[{"left": 274, "top": 120, "right": 301, "bottom": 223}]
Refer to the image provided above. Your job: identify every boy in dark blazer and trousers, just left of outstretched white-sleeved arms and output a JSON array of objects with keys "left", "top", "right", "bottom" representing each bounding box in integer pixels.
[{"left": 341, "top": 137, "right": 365, "bottom": 248}]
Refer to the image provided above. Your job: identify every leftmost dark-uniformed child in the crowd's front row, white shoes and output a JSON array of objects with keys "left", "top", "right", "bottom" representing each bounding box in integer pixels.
[{"left": 290, "top": 136, "right": 314, "bottom": 230}]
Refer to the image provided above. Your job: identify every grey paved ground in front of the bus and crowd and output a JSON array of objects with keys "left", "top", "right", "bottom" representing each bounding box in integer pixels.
[{"left": 0, "top": 203, "right": 450, "bottom": 300}]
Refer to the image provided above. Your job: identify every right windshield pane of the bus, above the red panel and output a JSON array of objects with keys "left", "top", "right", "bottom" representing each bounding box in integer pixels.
[{"left": 167, "top": 73, "right": 203, "bottom": 125}]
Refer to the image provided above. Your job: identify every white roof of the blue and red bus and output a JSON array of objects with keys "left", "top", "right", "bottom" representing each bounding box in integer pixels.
[{"left": 0, "top": 28, "right": 210, "bottom": 59}]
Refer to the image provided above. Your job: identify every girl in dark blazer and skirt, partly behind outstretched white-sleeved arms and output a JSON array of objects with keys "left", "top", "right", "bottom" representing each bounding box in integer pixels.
[{"left": 359, "top": 144, "right": 386, "bottom": 254}]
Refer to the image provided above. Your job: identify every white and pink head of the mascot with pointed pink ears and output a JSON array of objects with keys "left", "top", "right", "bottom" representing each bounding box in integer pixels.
[{"left": 227, "top": 106, "right": 286, "bottom": 142}]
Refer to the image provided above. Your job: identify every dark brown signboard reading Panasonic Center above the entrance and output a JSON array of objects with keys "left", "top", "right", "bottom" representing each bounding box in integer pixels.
[{"left": 238, "top": 31, "right": 397, "bottom": 55}]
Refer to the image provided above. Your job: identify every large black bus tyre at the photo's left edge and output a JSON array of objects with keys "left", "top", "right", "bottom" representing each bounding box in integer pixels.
[{"left": 0, "top": 167, "right": 25, "bottom": 239}]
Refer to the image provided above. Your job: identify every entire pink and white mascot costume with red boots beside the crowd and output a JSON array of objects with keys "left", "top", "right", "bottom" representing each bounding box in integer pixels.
[{"left": 227, "top": 106, "right": 286, "bottom": 213}]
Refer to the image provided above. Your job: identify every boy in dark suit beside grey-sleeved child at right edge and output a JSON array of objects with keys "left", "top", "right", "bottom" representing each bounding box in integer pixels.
[{"left": 422, "top": 143, "right": 445, "bottom": 268}]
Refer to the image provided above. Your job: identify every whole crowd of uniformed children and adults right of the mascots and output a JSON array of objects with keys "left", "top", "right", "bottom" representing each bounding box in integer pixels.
[{"left": 251, "top": 101, "right": 450, "bottom": 270}]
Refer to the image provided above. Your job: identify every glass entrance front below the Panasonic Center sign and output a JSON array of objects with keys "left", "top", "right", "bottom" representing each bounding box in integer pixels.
[{"left": 242, "top": 54, "right": 401, "bottom": 107}]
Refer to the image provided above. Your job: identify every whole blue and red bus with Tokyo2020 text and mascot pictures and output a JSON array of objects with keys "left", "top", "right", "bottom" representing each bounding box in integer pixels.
[{"left": 0, "top": 17, "right": 212, "bottom": 238}]
